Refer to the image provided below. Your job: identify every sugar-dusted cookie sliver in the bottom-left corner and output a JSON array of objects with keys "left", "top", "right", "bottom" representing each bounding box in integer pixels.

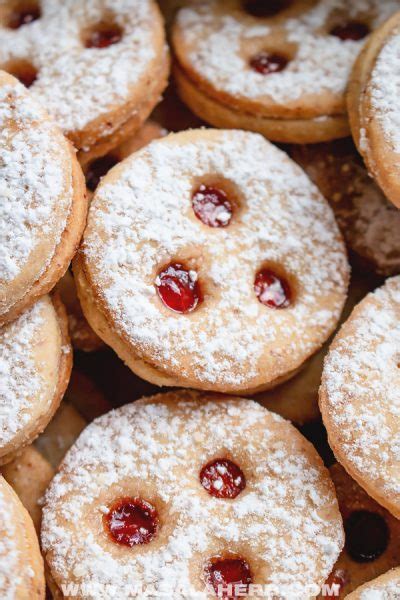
[{"left": 0, "top": 476, "right": 45, "bottom": 600}]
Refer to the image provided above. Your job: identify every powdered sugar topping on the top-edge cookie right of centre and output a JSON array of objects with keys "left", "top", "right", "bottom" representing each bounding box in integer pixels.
[{"left": 177, "top": 0, "right": 399, "bottom": 105}]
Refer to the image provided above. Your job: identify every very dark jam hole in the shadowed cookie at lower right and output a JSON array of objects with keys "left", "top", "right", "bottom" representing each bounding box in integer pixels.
[{"left": 344, "top": 510, "right": 390, "bottom": 563}]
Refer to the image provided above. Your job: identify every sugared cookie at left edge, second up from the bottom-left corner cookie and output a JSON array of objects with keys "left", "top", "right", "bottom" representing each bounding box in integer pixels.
[{"left": 0, "top": 296, "right": 72, "bottom": 464}]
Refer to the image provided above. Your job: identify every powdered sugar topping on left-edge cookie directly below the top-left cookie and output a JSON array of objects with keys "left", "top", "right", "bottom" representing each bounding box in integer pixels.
[{"left": 0, "top": 79, "right": 72, "bottom": 295}]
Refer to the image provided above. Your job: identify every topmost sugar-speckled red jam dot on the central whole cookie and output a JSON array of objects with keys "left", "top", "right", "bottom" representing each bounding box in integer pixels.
[{"left": 192, "top": 185, "right": 233, "bottom": 227}]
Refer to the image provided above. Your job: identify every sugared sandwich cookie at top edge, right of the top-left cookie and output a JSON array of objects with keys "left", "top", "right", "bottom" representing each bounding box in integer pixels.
[{"left": 172, "top": 0, "right": 399, "bottom": 143}]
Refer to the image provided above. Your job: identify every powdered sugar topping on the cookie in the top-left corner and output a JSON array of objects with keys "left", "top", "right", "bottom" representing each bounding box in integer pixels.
[{"left": 0, "top": 0, "right": 162, "bottom": 133}]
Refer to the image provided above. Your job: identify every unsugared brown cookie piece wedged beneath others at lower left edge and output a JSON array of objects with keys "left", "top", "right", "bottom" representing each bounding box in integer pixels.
[{"left": 1, "top": 446, "right": 54, "bottom": 534}]
